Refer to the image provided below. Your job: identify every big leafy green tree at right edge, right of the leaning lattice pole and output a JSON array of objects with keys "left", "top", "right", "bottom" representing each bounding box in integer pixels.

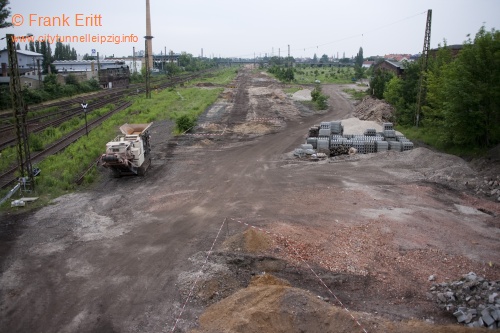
[{"left": 428, "top": 27, "right": 500, "bottom": 146}]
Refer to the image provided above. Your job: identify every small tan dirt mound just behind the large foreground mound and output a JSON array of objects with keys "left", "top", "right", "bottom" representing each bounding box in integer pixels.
[{"left": 222, "top": 229, "right": 272, "bottom": 253}]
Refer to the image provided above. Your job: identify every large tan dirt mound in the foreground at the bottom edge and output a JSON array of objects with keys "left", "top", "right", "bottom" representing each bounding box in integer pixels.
[{"left": 191, "top": 274, "right": 476, "bottom": 333}]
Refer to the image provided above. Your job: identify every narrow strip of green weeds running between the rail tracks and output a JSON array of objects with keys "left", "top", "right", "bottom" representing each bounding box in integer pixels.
[{"left": 0, "top": 102, "right": 132, "bottom": 188}]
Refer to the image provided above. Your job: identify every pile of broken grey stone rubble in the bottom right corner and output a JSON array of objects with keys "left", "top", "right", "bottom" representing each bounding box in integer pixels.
[{"left": 429, "top": 272, "right": 500, "bottom": 329}]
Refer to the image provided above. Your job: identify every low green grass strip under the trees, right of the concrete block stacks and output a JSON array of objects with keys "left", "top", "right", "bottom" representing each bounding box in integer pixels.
[{"left": 395, "top": 126, "right": 488, "bottom": 158}]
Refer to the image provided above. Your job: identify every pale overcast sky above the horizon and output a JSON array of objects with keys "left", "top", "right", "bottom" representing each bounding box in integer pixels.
[{"left": 0, "top": 0, "right": 500, "bottom": 58}]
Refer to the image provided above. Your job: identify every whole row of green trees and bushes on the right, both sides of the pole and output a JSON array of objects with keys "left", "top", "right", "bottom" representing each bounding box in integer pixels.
[{"left": 370, "top": 27, "right": 500, "bottom": 148}]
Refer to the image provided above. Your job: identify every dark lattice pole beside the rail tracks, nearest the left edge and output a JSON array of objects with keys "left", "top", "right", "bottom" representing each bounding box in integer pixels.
[{"left": 5, "top": 34, "right": 35, "bottom": 190}]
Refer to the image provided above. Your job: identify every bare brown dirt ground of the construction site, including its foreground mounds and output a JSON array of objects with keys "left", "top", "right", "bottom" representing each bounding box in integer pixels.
[{"left": 0, "top": 68, "right": 500, "bottom": 333}]
